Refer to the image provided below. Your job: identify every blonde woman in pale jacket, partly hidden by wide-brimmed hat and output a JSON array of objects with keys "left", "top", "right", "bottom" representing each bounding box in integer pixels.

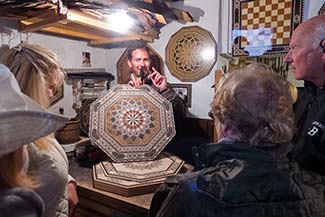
[{"left": 0, "top": 43, "right": 78, "bottom": 217}]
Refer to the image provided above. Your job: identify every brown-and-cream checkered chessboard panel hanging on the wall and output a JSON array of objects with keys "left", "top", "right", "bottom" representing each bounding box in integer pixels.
[{"left": 232, "top": 0, "right": 303, "bottom": 56}]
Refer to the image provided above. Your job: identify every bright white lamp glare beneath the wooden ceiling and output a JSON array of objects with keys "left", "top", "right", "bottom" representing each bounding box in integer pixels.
[{"left": 108, "top": 11, "right": 133, "bottom": 33}]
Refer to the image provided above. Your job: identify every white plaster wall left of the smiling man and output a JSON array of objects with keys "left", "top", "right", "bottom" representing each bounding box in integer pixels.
[{"left": 0, "top": 20, "right": 111, "bottom": 118}]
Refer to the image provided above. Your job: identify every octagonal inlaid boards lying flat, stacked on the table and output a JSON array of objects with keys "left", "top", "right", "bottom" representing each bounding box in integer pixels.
[{"left": 93, "top": 153, "right": 184, "bottom": 196}]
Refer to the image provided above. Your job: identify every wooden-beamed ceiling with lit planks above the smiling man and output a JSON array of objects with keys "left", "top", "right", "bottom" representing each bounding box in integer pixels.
[{"left": 0, "top": 0, "right": 203, "bottom": 47}]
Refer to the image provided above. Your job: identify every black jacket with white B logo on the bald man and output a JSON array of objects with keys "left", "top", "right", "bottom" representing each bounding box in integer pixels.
[{"left": 289, "top": 81, "right": 325, "bottom": 176}]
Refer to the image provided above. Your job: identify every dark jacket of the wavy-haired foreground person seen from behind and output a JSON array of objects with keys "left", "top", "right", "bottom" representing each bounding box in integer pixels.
[{"left": 149, "top": 141, "right": 325, "bottom": 217}]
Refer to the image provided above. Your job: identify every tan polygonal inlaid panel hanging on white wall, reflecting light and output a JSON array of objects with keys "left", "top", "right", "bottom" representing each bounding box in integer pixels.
[{"left": 166, "top": 26, "right": 217, "bottom": 82}]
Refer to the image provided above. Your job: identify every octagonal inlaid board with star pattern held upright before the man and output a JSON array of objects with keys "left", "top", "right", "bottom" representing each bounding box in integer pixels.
[{"left": 89, "top": 85, "right": 176, "bottom": 162}]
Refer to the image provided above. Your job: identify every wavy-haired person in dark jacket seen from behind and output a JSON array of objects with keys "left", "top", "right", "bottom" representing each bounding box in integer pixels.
[{"left": 149, "top": 63, "right": 325, "bottom": 217}]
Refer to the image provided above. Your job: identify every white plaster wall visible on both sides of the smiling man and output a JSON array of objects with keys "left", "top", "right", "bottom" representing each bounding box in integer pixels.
[{"left": 0, "top": 0, "right": 219, "bottom": 118}]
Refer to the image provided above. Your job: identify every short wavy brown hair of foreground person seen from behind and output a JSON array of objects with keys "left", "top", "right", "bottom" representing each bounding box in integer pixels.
[{"left": 211, "top": 63, "right": 294, "bottom": 146}]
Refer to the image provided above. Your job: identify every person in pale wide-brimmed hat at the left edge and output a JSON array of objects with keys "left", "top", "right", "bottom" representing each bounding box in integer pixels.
[{"left": 0, "top": 64, "right": 68, "bottom": 217}]
